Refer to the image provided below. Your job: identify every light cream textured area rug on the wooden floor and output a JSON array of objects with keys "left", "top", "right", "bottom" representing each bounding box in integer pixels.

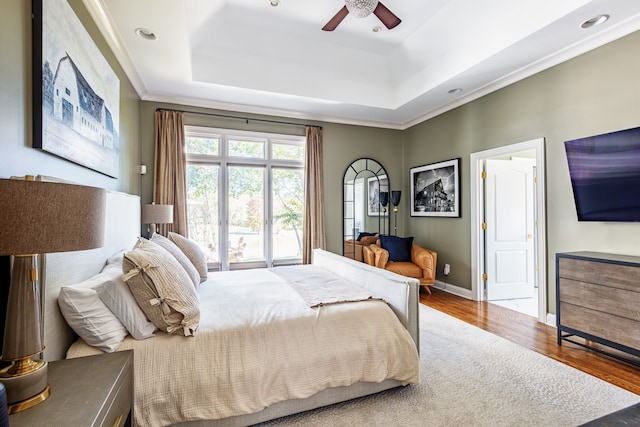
[{"left": 260, "top": 304, "right": 640, "bottom": 427}]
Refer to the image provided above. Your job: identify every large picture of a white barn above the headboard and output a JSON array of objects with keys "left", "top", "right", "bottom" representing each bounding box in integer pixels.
[{"left": 32, "top": 0, "right": 120, "bottom": 178}]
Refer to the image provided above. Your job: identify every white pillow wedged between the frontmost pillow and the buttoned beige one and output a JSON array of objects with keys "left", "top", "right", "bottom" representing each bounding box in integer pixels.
[{"left": 95, "top": 263, "right": 156, "bottom": 340}]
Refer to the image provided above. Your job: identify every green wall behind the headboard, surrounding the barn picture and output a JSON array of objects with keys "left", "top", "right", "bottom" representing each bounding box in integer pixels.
[{"left": 0, "top": 0, "right": 140, "bottom": 194}]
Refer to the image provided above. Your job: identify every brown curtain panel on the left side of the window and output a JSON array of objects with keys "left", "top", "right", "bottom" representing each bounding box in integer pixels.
[{"left": 153, "top": 111, "right": 188, "bottom": 236}]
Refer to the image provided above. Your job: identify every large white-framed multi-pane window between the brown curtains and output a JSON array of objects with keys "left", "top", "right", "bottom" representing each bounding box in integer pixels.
[{"left": 185, "top": 126, "right": 304, "bottom": 270}]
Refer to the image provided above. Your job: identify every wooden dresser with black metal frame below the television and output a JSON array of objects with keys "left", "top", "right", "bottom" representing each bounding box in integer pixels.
[{"left": 556, "top": 252, "right": 640, "bottom": 365}]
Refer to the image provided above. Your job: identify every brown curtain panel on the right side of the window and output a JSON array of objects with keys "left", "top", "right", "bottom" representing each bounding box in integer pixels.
[{"left": 302, "top": 126, "right": 326, "bottom": 264}]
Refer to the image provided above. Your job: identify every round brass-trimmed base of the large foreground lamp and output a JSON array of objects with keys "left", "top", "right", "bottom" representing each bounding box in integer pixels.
[{"left": 0, "top": 360, "right": 51, "bottom": 414}]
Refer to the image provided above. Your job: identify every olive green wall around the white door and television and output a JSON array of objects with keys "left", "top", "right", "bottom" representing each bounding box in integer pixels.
[{"left": 403, "top": 32, "right": 640, "bottom": 312}]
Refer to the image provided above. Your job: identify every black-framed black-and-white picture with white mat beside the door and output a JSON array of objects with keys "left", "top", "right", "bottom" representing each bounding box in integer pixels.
[{"left": 409, "top": 158, "right": 460, "bottom": 218}]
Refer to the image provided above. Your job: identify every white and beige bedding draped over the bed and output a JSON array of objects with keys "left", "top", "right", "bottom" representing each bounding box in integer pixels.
[{"left": 67, "top": 266, "right": 419, "bottom": 426}]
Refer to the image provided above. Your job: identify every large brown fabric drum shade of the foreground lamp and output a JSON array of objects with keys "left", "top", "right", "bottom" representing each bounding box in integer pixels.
[{"left": 0, "top": 179, "right": 106, "bottom": 255}]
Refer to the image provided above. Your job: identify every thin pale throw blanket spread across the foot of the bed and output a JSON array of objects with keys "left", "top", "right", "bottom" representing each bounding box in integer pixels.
[{"left": 271, "top": 265, "right": 382, "bottom": 308}]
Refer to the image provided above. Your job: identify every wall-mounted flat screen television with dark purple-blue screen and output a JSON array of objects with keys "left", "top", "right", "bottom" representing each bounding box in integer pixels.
[{"left": 564, "top": 128, "right": 640, "bottom": 222}]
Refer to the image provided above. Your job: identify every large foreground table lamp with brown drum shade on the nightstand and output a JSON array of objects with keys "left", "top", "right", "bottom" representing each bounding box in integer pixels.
[{"left": 0, "top": 177, "right": 106, "bottom": 414}]
